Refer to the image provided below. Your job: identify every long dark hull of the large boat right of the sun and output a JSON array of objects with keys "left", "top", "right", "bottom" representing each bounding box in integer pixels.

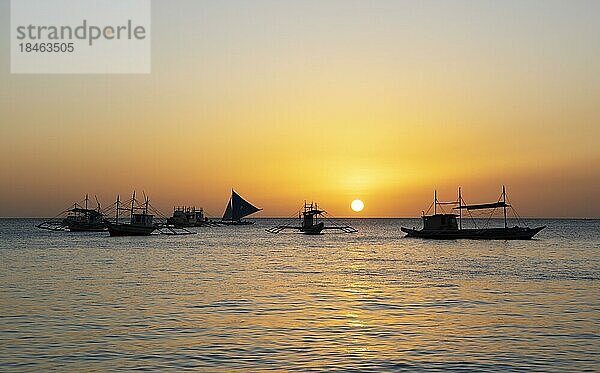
[{"left": 400, "top": 225, "right": 546, "bottom": 240}]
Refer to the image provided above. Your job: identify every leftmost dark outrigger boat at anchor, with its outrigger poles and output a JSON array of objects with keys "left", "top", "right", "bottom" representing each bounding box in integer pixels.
[{"left": 36, "top": 194, "right": 106, "bottom": 232}]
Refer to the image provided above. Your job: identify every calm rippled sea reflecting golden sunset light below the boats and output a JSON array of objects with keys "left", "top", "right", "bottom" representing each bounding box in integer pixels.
[{"left": 0, "top": 219, "right": 600, "bottom": 371}]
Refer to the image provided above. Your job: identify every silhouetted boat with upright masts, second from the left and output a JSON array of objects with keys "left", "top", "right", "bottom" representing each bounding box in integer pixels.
[{"left": 104, "top": 192, "right": 159, "bottom": 236}]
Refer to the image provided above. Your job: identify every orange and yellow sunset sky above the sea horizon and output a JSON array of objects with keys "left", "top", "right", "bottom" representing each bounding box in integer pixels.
[{"left": 0, "top": 0, "right": 600, "bottom": 218}]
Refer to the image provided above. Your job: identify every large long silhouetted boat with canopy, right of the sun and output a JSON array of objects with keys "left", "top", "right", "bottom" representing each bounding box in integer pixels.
[{"left": 400, "top": 186, "right": 546, "bottom": 240}]
